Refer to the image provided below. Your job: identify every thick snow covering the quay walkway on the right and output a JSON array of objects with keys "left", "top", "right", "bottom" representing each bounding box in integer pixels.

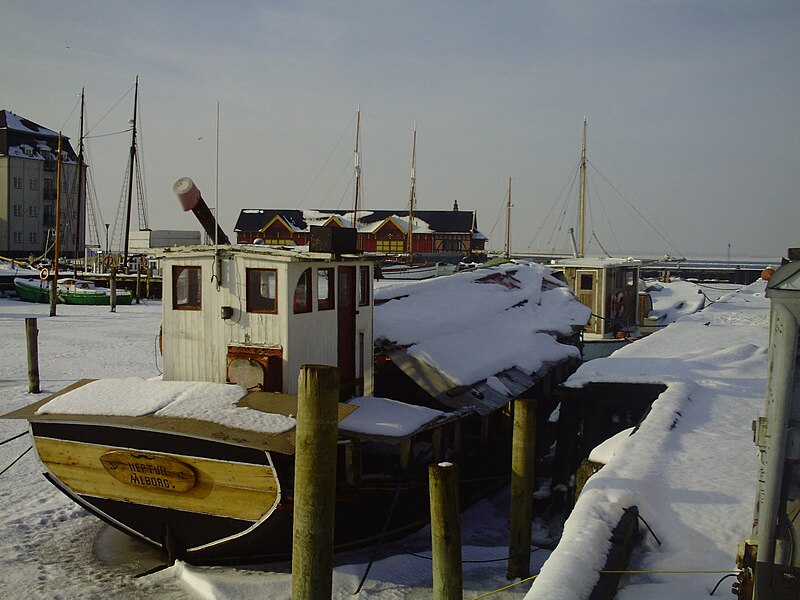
[{"left": 526, "top": 281, "right": 769, "bottom": 600}]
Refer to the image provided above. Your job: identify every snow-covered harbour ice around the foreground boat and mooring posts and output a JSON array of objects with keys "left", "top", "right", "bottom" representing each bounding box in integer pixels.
[{"left": 0, "top": 298, "right": 549, "bottom": 600}]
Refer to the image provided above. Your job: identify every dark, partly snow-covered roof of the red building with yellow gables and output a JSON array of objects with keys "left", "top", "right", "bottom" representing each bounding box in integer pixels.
[{"left": 234, "top": 208, "right": 479, "bottom": 234}]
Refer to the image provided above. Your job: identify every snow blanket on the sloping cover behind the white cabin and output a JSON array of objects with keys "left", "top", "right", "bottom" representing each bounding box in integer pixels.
[{"left": 373, "top": 262, "right": 590, "bottom": 386}]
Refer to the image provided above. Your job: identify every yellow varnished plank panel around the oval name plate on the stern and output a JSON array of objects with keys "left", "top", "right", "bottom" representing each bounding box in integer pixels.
[{"left": 35, "top": 438, "right": 280, "bottom": 521}]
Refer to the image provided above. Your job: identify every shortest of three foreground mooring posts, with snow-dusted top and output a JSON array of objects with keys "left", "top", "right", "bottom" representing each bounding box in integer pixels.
[{"left": 428, "top": 462, "right": 464, "bottom": 600}]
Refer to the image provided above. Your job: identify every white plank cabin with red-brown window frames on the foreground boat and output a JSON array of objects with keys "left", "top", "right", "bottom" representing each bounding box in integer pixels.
[{"left": 161, "top": 245, "right": 373, "bottom": 398}]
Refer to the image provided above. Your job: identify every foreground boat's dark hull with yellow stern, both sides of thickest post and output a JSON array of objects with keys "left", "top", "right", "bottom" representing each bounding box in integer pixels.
[{"left": 30, "top": 422, "right": 438, "bottom": 565}]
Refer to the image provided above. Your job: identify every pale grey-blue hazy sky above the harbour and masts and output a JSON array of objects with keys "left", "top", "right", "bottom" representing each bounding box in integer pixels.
[{"left": 0, "top": 0, "right": 800, "bottom": 258}]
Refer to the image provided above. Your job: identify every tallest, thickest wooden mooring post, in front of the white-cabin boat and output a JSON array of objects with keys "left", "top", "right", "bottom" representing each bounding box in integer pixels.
[{"left": 292, "top": 365, "right": 339, "bottom": 600}]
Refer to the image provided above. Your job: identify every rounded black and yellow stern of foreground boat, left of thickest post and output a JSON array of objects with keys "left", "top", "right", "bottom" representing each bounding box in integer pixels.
[{"left": 31, "top": 423, "right": 291, "bottom": 563}]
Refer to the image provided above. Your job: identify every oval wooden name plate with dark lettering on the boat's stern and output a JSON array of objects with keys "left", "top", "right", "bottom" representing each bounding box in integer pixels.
[{"left": 100, "top": 450, "right": 196, "bottom": 492}]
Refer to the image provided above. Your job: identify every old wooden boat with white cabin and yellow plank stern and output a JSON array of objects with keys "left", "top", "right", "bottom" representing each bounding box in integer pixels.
[{"left": 4, "top": 179, "right": 584, "bottom": 564}]
